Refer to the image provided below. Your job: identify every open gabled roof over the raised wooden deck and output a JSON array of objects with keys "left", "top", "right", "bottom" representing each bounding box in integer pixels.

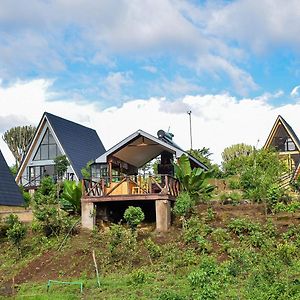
[{"left": 95, "top": 130, "right": 208, "bottom": 170}]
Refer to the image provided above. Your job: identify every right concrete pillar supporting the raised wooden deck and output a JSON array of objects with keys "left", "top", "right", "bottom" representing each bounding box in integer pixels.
[{"left": 155, "top": 200, "right": 171, "bottom": 232}]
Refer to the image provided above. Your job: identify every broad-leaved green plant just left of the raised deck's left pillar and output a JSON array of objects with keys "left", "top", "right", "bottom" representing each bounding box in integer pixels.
[{"left": 60, "top": 180, "right": 82, "bottom": 214}]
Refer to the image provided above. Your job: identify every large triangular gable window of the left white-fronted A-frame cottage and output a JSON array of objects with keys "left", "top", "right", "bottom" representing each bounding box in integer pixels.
[{"left": 33, "top": 129, "right": 61, "bottom": 160}]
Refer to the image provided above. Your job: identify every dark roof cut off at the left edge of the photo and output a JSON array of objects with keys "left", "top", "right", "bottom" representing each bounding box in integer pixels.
[{"left": 0, "top": 151, "right": 24, "bottom": 206}]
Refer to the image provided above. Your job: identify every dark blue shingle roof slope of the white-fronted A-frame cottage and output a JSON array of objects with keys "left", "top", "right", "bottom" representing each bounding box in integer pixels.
[{"left": 45, "top": 112, "right": 105, "bottom": 178}]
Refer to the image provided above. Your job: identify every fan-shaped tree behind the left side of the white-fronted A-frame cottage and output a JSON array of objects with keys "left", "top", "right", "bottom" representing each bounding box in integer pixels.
[{"left": 2, "top": 126, "right": 36, "bottom": 167}]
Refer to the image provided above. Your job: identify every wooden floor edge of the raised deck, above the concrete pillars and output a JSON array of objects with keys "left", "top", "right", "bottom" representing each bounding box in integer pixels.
[{"left": 81, "top": 194, "right": 176, "bottom": 203}]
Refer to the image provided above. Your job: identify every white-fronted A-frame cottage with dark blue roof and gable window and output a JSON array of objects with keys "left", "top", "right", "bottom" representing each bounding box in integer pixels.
[{"left": 16, "top": 112, "right": 105, "bottom": 190}]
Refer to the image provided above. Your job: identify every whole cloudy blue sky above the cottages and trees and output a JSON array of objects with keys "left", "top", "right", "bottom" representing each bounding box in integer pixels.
[{"left": 0, "top": 0, "right": 300, "bottom": 165}]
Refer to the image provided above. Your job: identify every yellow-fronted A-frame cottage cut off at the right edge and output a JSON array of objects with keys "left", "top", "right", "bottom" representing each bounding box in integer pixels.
[{"left": 264, "top": 115, "right": 300, "bottom": 179}]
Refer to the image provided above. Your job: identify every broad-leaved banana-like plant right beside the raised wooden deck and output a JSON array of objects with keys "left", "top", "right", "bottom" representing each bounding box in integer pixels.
[{"left": 174, "top": 155, "right": 214, "bottom": 198}]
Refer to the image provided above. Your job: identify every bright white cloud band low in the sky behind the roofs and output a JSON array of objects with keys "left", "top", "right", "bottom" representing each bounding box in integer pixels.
[{"left": 0, "top": 80, "right": 300, "bottom": 168}]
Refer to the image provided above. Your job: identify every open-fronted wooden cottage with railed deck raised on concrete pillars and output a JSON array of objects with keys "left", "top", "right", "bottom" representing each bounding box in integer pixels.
[{"left": 82, "top": 130, "right": 207, "bottom": 231}]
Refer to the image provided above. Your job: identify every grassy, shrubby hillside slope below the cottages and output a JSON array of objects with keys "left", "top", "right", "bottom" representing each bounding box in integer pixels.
[{"left": 0, "top": 206, "right": 300, "bottom": 300}]
